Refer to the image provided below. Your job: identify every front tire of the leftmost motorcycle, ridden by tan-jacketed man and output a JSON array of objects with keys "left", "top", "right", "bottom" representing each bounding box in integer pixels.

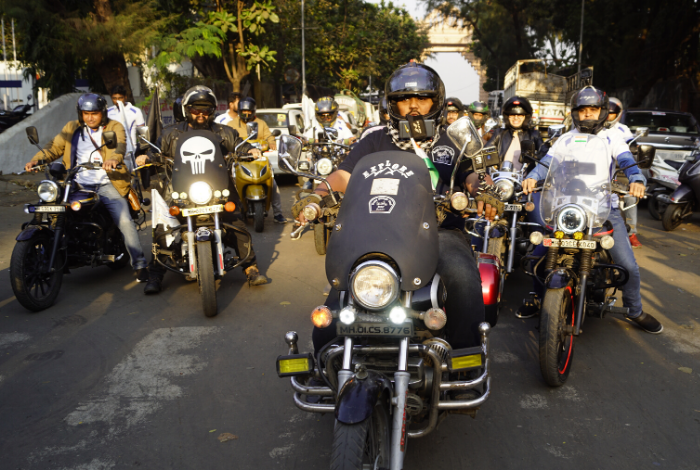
[{"left": 10, "top": 237, "right": 64, "bottom": 312}]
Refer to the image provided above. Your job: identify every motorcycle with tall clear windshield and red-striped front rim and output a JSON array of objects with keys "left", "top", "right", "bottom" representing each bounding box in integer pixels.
[{"left": 528, "top": 131, "right": 654, "bottom": 387}]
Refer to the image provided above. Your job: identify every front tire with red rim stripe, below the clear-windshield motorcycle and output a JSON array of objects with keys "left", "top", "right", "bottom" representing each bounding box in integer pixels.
[{"left": 539, "top": 287, "right": 575, "bottom": 387}]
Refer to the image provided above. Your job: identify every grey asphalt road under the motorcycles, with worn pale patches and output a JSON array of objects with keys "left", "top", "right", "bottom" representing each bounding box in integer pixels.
[{"left": 0, "top": 177, "right": 700, "bottom": 470}]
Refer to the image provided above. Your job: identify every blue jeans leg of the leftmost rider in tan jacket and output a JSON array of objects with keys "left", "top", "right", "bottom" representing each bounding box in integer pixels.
[{"left": 83, "top": 183, "right": 148, "bottom": 269}]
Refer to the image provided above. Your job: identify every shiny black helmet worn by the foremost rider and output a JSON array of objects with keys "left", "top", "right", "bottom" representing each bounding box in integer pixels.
[{"left": 384, "top": 62, "right": 445, "bottom": 127}]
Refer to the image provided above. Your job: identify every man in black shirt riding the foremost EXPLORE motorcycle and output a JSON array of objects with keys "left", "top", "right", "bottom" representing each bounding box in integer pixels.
[{"left": 299, "top": 62, "right": 496, "bottom": 350}]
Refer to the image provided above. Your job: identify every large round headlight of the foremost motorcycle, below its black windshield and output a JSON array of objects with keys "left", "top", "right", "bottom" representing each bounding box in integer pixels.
[{"left": 350, "top": 260, "right": 399, "bottom": 310}]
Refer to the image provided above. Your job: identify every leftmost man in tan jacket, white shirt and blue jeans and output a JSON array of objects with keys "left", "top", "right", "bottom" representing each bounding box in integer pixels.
[{"left": 24, "top": 93, "right": 148, "bottom": 282}]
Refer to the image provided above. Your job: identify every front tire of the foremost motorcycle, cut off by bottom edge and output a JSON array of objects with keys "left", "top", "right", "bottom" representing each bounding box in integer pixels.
[{"left": 331, "top": 400, "right": 391, "bottom": 470}]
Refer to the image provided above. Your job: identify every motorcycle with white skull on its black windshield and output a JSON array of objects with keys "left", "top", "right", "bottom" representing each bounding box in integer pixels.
[{"left": 140, "top": 130, "right": 252, "bottom": 317}]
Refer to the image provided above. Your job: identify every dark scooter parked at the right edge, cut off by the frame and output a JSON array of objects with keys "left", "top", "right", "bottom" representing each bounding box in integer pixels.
[{"left": 656, "top": 150, "right": 700, "bottom": 232}]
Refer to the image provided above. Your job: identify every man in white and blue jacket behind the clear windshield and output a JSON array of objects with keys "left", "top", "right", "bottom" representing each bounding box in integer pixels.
[{"left": 523, "top": 86, "right": 663, "bottom": 334}]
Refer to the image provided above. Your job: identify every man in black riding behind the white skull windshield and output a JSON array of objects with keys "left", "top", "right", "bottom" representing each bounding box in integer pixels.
[{"left": 136, "top": 85, "right": 267, "bottom": 294}]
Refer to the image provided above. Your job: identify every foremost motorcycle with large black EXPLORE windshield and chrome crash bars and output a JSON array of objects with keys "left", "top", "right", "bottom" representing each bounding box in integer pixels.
[{"left": 277, "top": 118, "right": 491, "bottom": 470}]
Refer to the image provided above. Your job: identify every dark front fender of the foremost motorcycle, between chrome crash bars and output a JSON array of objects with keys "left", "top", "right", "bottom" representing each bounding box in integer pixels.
[{"left": 335, "top": 371, "right": 392, "bottom": 424}]
